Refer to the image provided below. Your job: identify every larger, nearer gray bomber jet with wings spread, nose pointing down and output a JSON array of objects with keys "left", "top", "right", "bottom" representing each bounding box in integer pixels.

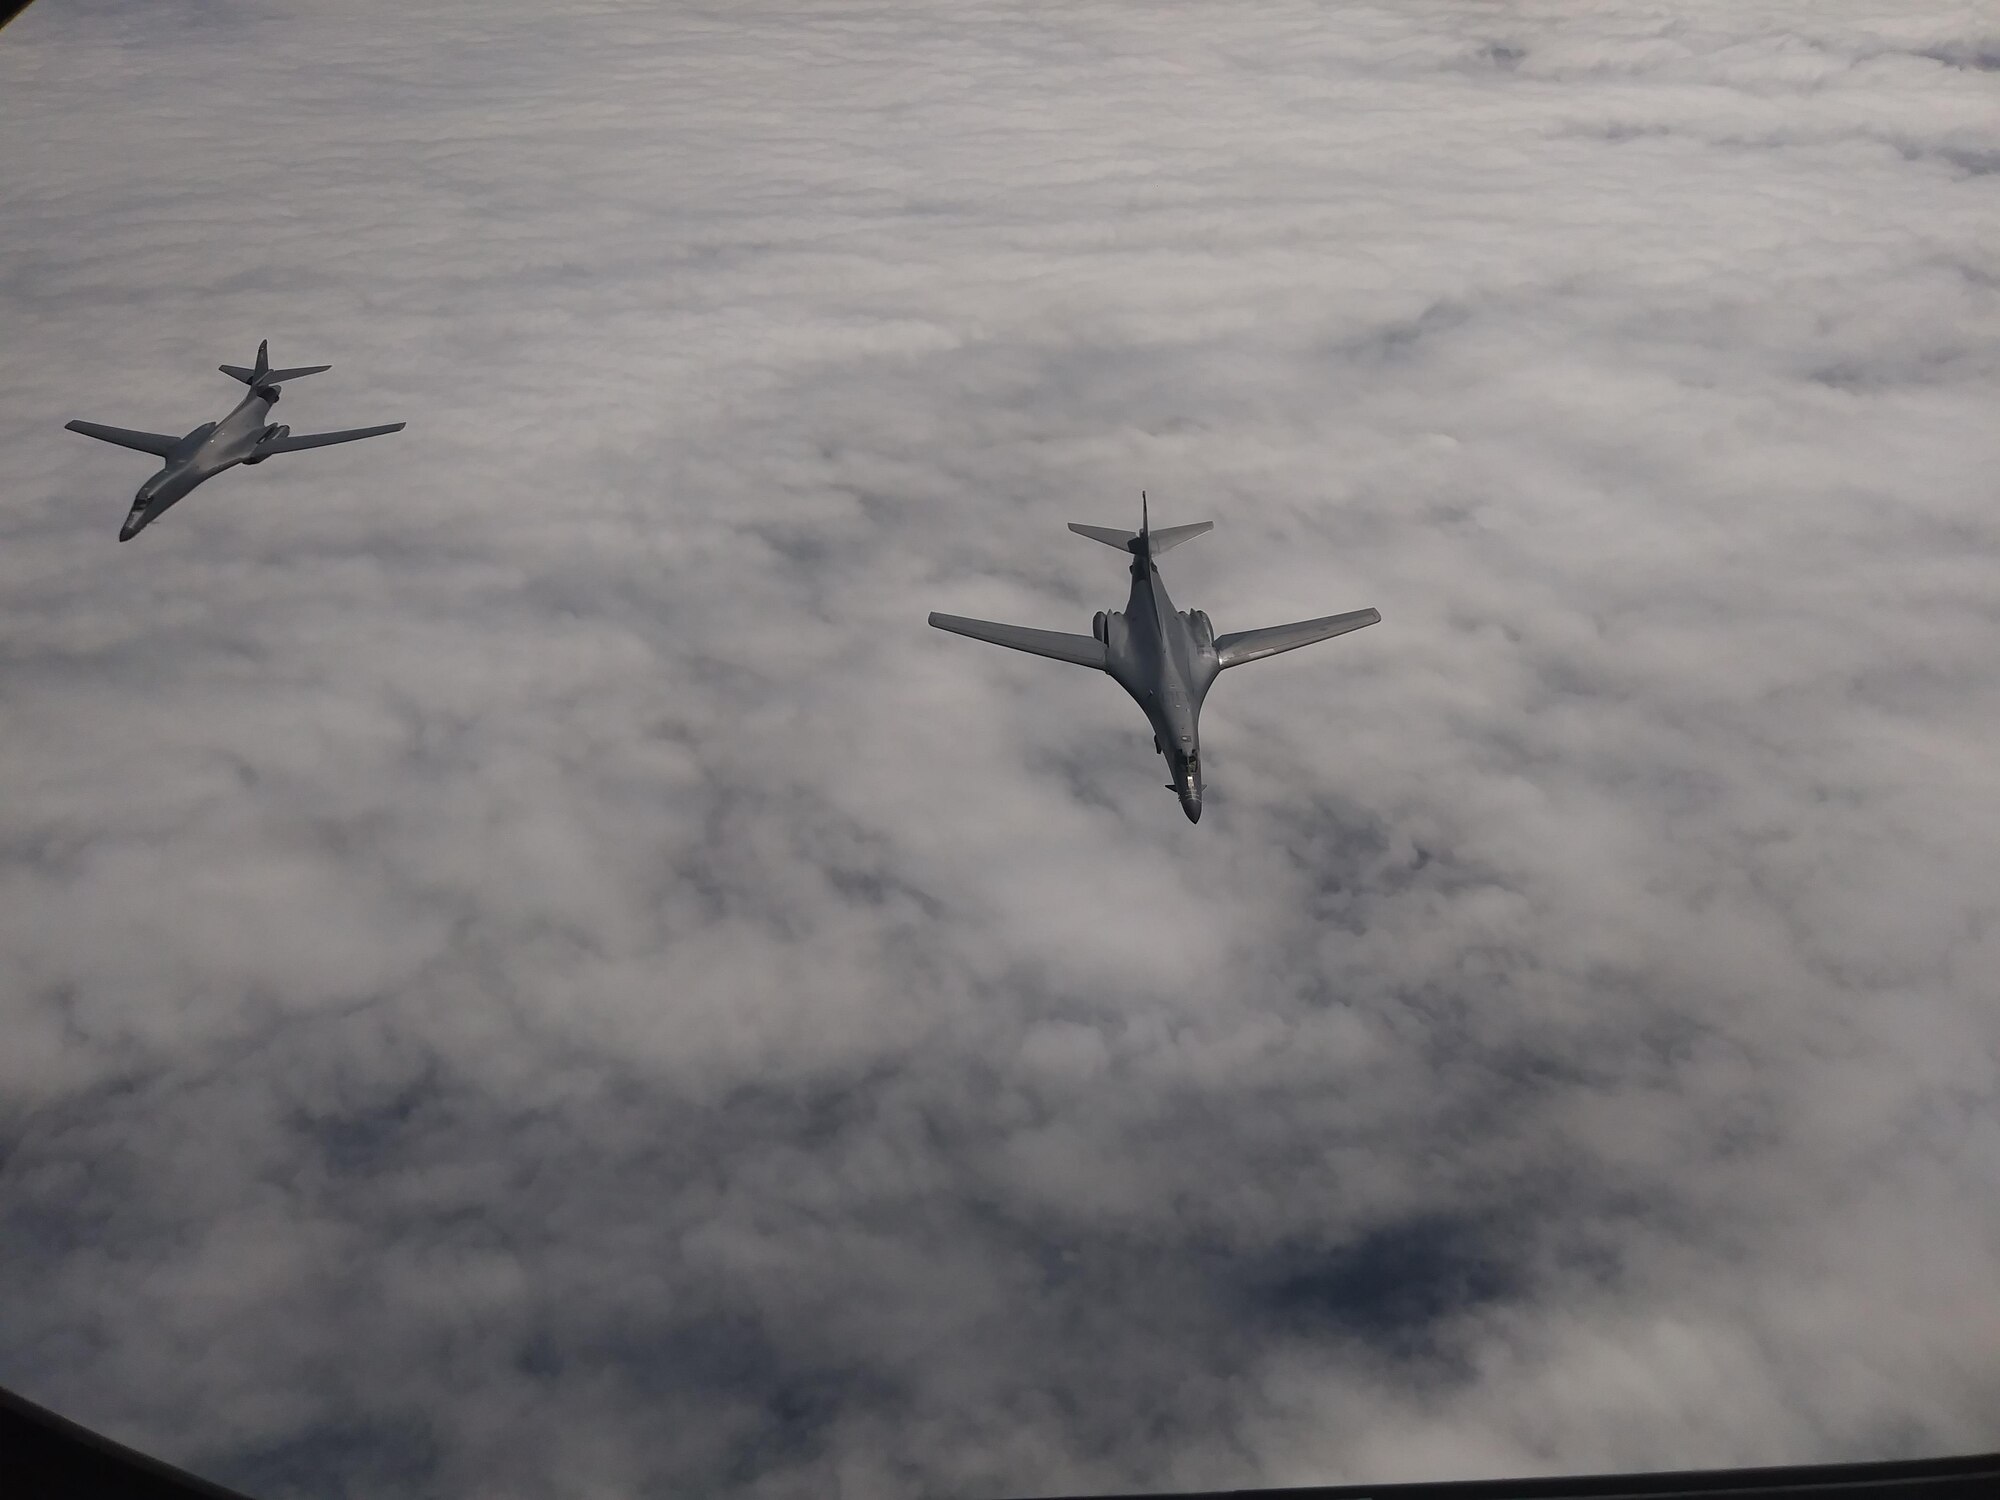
[{"left": 930, "top": 492, "right": 1382, "bottom": 822}]
